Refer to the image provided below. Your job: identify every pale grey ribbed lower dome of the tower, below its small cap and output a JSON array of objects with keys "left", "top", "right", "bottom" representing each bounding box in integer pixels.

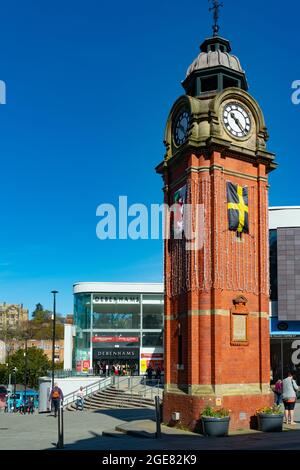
[{"left": 186, "top": 50, "right": 244, "bottom": 76}]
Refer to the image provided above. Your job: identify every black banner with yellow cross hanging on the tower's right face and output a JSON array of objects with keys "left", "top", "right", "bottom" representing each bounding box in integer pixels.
[{"left": 227, "top": 182, "right": 249, "bottom": 233}]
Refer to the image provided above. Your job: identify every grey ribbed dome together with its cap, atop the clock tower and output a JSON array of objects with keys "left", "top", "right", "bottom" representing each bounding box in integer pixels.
[{"left": 186, "top": 37, "right": 244, "bottom": 77}]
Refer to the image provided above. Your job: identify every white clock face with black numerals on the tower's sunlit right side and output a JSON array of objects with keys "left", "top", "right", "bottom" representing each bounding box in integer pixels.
[{"left": 223, "top": 103, "right": 251, "bottom": 138}]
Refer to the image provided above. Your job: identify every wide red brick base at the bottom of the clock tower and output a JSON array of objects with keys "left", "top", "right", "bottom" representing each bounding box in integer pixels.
[{"left": 163, "top": 392, "right": 274, "bottom": 431}]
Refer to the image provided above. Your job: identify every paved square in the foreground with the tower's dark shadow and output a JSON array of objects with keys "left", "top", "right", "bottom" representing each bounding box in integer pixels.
[{"left": 0, "top": 403, "right": 300, "bottom": 451}]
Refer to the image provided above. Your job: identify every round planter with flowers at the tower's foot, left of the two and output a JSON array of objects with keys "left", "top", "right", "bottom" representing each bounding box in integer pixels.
[{"left": 201, "top": 406, "right": 230, "bottom": 437}]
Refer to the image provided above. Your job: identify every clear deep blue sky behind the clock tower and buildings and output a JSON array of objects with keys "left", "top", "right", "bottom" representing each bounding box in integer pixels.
[{"left": 0, "top": 0, "right": 300, "bottom": 314}]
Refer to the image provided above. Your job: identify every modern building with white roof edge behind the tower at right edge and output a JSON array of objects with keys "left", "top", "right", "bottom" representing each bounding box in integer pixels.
[{"left": 269, "top": 206, "right": 300, "bottom": 383}]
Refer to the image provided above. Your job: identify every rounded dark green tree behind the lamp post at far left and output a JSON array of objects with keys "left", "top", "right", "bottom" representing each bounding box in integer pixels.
[{"left": 6, "top": 347, "right": 51, "bottom": 388}]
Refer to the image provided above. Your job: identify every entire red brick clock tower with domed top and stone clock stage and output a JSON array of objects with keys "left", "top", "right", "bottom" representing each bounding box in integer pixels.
[{"left": 156, "top": 32, "right": 276, "bottom": 428}]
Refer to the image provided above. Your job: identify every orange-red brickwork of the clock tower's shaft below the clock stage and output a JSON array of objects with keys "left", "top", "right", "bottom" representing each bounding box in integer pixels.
[{"left": 159, "top": 147, "right": 273, "bottom": 428}]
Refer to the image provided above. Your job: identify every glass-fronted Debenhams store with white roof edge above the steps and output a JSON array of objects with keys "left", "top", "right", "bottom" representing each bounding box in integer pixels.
[{"left": 73, "top": 282, "right": 164, "bottom": 374}]
